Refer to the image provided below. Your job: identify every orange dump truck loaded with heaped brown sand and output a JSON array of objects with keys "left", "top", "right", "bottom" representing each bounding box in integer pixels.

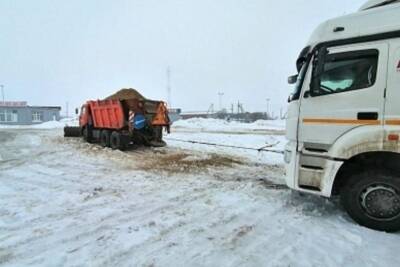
[{"left": 64, "top": 89, "right": 170, "bottom": 150}]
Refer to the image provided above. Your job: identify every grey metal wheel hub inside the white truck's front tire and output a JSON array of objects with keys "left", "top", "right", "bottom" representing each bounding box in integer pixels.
[{"left": 361, "top": 184, "right": 400, "bottom": 219}]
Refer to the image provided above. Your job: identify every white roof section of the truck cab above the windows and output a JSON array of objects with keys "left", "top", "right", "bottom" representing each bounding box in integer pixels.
[{"left": 308, "top": 1, "right": 400, "bottom": 46}]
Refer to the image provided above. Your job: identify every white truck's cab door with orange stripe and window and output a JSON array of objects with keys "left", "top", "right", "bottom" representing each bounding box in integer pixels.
[{"left": 298, "top": 42, "right": 388, "bottom": 151}]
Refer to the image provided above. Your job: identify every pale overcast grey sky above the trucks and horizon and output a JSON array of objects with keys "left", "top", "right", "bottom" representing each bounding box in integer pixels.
[{"left": 0, "top": 0, "right": 366, "bottom": 115}]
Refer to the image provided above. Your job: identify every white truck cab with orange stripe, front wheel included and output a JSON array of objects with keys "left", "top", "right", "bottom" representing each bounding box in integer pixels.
[{"left": 285, "top": 0, "right": 400, "bottom": 231}]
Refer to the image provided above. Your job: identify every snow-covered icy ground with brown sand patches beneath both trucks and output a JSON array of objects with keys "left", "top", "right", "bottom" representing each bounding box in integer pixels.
[{"left": 0, "top": 129, "right": 400, "bottom": 267}]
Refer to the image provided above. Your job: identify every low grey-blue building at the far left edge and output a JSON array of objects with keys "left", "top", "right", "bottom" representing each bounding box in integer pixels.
[{"left": 0, "top": 101, "right": 61, "bottom": 125}]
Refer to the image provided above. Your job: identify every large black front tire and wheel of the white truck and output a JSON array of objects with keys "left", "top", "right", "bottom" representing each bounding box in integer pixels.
[{"left": 340, "top": 169, "right": 400, "bottom": 232}]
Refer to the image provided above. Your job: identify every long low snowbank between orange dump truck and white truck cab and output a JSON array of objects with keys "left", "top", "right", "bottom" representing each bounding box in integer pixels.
[{"left": 173, "top": 118, "right": 285, "bottom": 131}]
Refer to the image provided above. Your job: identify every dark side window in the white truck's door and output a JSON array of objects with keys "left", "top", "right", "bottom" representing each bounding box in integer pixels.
[{"left": 313, "top": 49, "right": 379, "bottom": 96}]
